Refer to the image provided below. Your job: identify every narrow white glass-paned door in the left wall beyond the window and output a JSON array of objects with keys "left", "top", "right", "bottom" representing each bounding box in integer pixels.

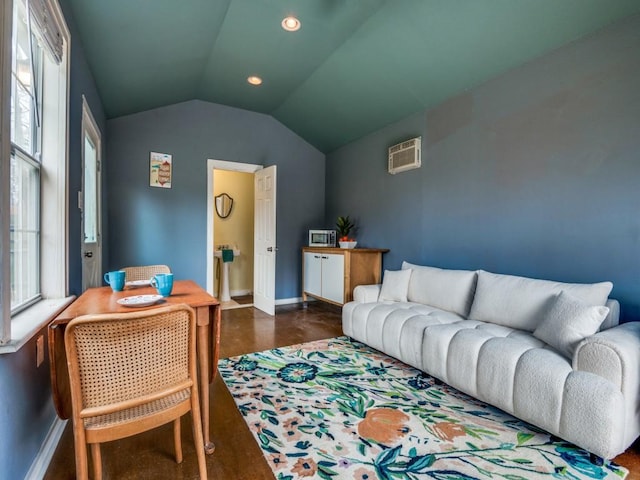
[{"left": 78, "top": 96, "right": 102, "bottom": 291}]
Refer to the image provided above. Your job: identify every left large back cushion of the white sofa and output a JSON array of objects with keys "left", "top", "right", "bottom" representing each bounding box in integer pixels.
[{"left": 402, "top": 262, "right": 477, "bottom": 318}]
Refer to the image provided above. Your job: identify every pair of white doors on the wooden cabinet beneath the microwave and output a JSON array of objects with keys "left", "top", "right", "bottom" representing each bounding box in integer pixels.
[{"left": 304, "top": 252, "right": 344, "bottom": 304}]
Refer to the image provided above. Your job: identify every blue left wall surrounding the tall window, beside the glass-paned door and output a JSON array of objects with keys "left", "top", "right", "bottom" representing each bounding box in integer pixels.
[{"left": 0, "top": 0, "right": 105, "bottom": 479}]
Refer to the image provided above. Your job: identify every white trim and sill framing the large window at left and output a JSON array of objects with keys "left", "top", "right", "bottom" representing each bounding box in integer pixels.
[{"left": 0, "top": 0, "right": 73, "bottom": 354}]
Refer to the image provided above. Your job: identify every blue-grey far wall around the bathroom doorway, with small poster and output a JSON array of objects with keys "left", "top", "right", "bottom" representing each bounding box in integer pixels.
[{"left": 107, "top": 100, "right": 325, "bottom": 299}]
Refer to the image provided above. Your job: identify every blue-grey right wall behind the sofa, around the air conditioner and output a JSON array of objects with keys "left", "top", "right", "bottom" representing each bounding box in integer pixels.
[{"left": 326, "top": 16, "right": 640, "bottom": 320}]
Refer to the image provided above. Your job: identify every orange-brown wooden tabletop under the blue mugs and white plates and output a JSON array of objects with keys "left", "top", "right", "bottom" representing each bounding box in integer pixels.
[{"left": 51, "top": 280, "right": 215, "bottom": 325}]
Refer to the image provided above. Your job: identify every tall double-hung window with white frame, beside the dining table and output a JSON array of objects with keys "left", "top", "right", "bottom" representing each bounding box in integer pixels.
[{"left": 0, "top": 0, "right": 69, "bottom": 346}]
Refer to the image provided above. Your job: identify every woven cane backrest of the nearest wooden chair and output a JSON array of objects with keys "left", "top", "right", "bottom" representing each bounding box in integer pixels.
[{"left": 65, "top": 305, "right": 197, "bottom": 413}]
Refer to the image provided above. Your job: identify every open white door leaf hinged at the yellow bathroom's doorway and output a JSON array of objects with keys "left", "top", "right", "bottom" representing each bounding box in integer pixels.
[{"left": 253, "top": 165, "right": 277, "bottom": 315}]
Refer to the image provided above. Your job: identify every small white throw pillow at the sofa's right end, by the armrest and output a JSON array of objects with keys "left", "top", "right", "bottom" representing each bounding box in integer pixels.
[{"left": 533, "top": 291, "right": 609, "bottom": 358}]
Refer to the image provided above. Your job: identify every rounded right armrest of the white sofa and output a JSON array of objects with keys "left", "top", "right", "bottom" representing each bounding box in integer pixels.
[{"left": 573, "top": 322, "right": 640, "bottom": 396}]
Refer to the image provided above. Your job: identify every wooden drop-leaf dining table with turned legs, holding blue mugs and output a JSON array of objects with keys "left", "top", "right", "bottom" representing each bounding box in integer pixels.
[{"left": 48, "top": 280, "right": 220, "bottom": 453}]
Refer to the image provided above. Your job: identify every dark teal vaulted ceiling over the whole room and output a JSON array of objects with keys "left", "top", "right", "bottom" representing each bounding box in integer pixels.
[{"left": 68, "top": 0, "right": 640, "bottom": 152}]
